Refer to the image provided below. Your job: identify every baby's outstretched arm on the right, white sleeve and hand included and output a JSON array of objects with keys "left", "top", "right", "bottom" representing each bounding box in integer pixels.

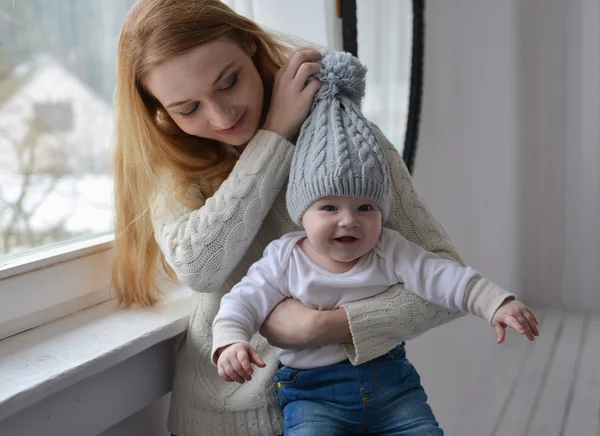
[{"left": 384, "top": 230, "right": 539, "bottom": 343}]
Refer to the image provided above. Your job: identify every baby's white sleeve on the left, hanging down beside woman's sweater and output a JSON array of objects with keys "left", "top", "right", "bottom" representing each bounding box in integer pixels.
[{"left": 211, "top": 240, "right": 290, "bottom": 363}]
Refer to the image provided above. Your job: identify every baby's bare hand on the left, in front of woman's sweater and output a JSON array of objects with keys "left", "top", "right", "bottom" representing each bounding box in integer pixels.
[{"left": 217, "top": 342, "right": 267, "bottom": 384}]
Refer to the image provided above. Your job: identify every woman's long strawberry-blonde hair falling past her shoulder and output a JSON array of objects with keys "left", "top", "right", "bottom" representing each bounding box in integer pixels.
[{"left": 112, "top": 0, "right": 289, "bottom": 307}]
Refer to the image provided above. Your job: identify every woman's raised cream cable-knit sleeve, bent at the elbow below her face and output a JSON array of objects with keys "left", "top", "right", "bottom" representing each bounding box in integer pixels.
[{"left": 151, "top": 130, "right": 294, "bottom": 292}]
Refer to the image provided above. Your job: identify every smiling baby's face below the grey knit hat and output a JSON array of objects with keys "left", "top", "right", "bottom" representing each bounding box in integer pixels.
[{"left": 302, "top": 197, "right": 382, "bottom": 262}]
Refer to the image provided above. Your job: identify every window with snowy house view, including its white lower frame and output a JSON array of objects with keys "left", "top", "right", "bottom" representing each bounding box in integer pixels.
[{"left": 0, "top": 0, "right": 134, "bottom": 339}]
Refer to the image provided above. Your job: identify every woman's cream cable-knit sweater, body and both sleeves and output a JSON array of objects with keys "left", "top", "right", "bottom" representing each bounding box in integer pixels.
[{"left": 151, "top": 126, "right": 462, "bottom": 436}]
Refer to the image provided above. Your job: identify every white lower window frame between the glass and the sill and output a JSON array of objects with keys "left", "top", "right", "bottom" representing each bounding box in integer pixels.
[{"left": 0, "top": 234, "right": 114, "bottom": 340}]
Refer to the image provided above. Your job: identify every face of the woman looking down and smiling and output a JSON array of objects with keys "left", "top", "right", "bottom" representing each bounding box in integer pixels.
[{"left": 144, "top": 37, "right": 263, "bottom": 146}]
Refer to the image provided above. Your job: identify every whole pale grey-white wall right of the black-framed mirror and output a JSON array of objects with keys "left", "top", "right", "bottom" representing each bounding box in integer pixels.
[{"left": 415, "top": 0, "right": 600, "bottom": 311}]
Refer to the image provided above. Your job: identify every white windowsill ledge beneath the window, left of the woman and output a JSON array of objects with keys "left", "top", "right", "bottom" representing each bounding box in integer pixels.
[{"left": 0, "top": 285, "right": 193, "bottom": 421}]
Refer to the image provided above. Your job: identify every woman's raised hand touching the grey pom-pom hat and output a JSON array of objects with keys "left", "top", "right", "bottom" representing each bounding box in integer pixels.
[{"left": 263, "top": 49, "right": 322, "bottom": 140}]
